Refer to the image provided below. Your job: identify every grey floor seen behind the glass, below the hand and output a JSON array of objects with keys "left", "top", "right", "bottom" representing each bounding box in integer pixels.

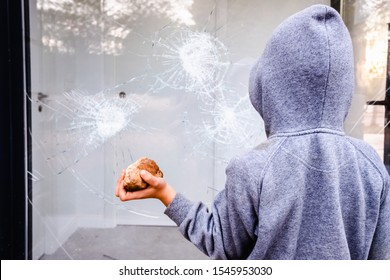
[{"left": 41, "top": 226, "right": 208, "bottom": 260}]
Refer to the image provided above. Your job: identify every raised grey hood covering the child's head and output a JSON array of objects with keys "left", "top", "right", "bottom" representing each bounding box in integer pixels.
[{"left": 249, "top": 5, "right": 354, "bottom": 136}]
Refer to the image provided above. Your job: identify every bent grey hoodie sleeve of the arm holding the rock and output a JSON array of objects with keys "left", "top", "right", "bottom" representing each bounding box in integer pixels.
[{"left": 165, "top": 160, "right": 259, "bottom": 259}]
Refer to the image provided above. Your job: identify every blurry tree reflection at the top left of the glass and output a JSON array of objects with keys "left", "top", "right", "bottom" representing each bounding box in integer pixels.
[{"left": 37, "top": 0, "right": 195, "bottom": 55}]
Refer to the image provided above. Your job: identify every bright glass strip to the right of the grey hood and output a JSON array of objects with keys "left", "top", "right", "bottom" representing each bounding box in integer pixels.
[{"left": 342, "top": 0, "right": 390, "bottom": 164}]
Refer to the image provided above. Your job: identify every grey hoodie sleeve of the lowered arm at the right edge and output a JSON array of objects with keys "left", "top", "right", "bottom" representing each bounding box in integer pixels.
[{"left": 368, "top": 175, "right": 390, "bottom": 260}]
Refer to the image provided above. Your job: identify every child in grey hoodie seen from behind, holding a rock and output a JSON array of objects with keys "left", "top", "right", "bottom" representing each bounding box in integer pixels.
[{"left": 116, "top": 5, "right": 390, "bottom": 259}]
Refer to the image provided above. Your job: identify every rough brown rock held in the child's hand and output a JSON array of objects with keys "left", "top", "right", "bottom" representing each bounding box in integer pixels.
[{"left": 124, "top": 157, "right": 163, "bottom": 192}]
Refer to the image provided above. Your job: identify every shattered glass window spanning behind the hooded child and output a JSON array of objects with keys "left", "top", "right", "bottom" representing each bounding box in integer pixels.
[{"left": 29, "top": 0, "right": 390, "bottom": 259}]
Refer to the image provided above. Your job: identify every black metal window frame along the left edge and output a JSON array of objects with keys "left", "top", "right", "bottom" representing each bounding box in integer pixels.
[{"left": 0, "top": 0, "right": 32, "bottom": 259}]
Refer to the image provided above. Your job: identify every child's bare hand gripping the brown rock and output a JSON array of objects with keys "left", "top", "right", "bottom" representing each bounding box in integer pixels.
[{"left": 115, "top": 170, "right": 176, "bottom": 206}]
